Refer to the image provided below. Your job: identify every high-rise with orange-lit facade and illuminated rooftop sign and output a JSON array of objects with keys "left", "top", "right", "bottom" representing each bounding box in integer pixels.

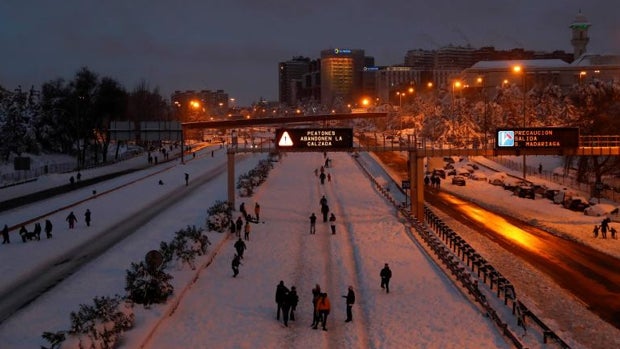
[{"left": 321, "top": 48, "right": 374, "bottom": 106}]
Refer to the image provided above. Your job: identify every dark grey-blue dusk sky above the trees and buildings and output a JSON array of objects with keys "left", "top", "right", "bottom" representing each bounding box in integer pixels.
[{"left": 0, "top": 0, "right": 620, "bottom": 105}]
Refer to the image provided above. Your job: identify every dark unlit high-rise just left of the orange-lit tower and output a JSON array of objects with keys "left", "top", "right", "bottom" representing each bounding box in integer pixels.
[{"left": 278, "top": 56, "right": 311, "bottom": 106}]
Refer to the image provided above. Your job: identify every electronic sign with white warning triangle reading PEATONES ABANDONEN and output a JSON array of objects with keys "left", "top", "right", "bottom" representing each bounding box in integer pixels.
[{"left": 276, "top": 128, "right": 353, "bottom": 150}]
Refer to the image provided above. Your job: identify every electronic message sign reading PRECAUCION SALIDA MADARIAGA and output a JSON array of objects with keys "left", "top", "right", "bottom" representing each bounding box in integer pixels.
[{"left": 495, "top": 127, "right": 579, "bottom": 149}]
